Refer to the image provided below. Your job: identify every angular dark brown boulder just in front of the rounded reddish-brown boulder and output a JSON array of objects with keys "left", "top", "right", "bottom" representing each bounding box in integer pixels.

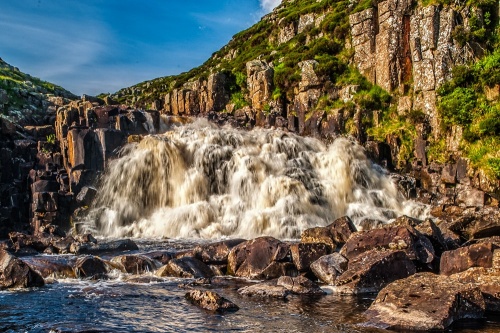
[{"left": 335, "top": 249, "right": 416, "bottom": 294}]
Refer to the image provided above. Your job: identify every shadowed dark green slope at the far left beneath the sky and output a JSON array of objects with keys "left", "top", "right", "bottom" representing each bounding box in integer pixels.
[{"left": 0, "top": 58, "right": 76, "bottom": 125}]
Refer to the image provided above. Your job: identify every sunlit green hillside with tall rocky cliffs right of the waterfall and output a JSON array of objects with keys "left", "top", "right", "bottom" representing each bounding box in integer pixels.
[{"left": 103, "top": 0, "right": 500, "bottom": 192}]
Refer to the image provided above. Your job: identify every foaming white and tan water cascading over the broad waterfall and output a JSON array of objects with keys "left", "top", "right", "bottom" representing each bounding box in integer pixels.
[{"left": 87, "top": 120, "right": 426, "bottom": 238}]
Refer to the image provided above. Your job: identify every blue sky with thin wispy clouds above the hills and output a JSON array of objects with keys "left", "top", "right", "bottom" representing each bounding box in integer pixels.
[{"left": 0, "top": 0, "right": 281, "bottom": 95}]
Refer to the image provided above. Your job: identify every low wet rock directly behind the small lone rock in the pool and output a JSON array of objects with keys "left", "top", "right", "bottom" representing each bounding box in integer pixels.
[{"left": 156, "top": 257, "right": 214, "bottom": 278}]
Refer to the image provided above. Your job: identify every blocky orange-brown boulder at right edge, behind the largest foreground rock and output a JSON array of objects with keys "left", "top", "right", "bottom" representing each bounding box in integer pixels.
[{"left": 440, "top": 243, "right": 499, "bottom": 275}]
